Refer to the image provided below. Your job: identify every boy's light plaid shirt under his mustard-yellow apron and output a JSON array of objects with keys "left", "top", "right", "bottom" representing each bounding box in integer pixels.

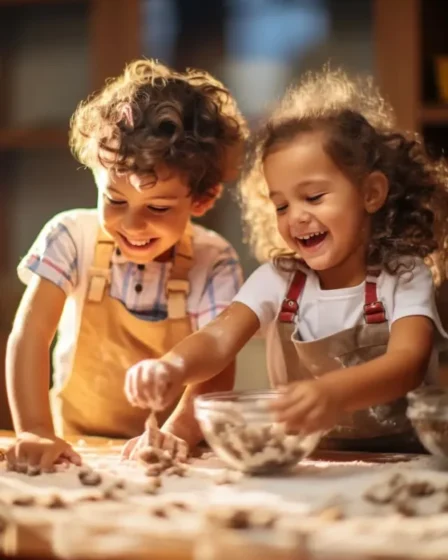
[{"left": 18, "top": 209, "right": 242, "bottom": 387}]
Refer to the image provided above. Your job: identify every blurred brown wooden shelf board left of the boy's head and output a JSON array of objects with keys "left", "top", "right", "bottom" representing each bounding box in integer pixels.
[{"left": 0, "top": 126, "right": 68, "bottom": 151}]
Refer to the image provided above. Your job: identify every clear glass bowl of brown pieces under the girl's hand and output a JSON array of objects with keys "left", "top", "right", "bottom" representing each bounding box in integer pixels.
[{"left": 195, "top": 391, "right": 322, "bottom": 474}]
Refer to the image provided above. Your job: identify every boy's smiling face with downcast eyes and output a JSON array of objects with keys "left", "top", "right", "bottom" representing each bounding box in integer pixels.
[{"left": 95, "top": 169, "right": 210, "bottom": 264}]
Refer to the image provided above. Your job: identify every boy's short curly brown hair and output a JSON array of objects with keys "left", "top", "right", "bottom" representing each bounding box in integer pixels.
[{"left": 70, "top": 60, "right": 247, "bottom": 198}]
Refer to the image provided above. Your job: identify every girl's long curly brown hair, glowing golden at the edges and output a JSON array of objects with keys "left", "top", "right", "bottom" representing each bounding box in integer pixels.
[{"left": 240, "top": 68, "right": 448, "bottom": 283}]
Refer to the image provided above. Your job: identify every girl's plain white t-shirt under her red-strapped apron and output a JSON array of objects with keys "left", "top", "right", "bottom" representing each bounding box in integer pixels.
[{"left": 234, "top": 259, "right": 448, "bottom": 383}]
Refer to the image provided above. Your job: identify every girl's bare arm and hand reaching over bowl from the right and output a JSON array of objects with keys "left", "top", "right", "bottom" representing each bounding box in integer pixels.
[{"left": 272, "top": 316, "right": 434, "bottom": 432}]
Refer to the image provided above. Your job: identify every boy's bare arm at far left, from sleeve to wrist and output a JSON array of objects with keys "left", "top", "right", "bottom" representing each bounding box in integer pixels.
[{"left": 6, "top": 275, "right": 66, "bottom": 436}]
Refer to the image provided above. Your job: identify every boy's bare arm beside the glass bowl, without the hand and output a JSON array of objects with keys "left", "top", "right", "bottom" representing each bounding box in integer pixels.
[{"left": 162, "top": 362, "right": 236, "bottom": 448}]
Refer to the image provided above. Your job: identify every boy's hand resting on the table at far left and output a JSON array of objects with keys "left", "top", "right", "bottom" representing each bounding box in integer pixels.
[{"left": 5, "top": 432, "right": 82, "bottom": 473}]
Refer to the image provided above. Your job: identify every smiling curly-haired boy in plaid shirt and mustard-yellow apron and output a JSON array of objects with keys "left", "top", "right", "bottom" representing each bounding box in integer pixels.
[{"left": 7, "top": 60, "right": 246, "bottom": 470}]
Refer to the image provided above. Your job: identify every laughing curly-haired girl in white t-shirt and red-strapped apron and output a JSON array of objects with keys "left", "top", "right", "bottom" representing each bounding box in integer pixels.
[{"left": 126, "top": 69, "right": 448, "bottom": 451}]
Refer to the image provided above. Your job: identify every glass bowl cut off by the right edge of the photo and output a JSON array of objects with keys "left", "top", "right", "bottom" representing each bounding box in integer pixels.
[{"left": 407, "top": 386, "right": 448, "bottom": 459}]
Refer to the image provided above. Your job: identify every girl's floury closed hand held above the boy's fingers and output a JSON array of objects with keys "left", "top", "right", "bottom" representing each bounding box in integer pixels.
[{"left": 124, "top": 360, "right": 184, "bottom": 410}]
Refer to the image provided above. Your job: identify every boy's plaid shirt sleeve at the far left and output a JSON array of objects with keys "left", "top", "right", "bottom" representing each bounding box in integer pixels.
[{"left": 18, "top": 216, "right": 78, "bottom": 294}]
